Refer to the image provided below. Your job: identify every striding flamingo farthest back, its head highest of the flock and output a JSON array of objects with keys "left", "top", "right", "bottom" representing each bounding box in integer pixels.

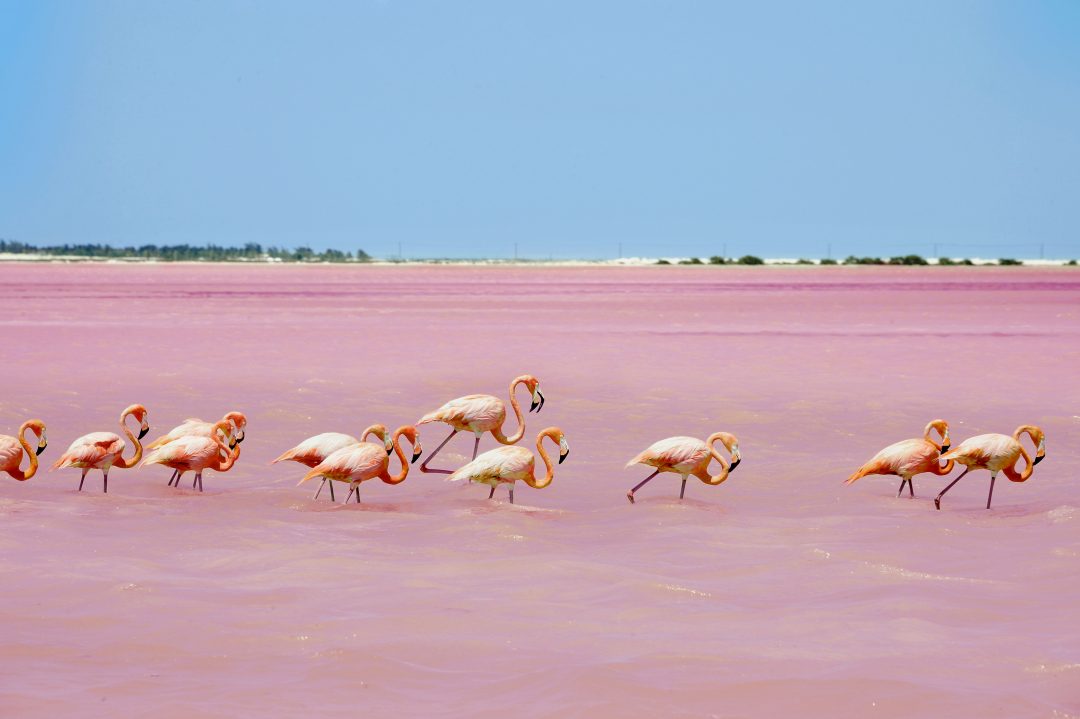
[{"left": 417, "top": 375, "right": 544, "bottom": 474}]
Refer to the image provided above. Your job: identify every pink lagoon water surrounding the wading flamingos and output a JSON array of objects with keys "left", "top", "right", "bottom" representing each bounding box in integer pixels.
[{"left": 0, "top": 264, "right": 1080, "bottom": 718}]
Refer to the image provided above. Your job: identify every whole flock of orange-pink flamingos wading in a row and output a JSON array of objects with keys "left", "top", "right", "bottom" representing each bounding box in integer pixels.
[{"left": 0, "top": 375, "right": 1047, "bottom": 510}]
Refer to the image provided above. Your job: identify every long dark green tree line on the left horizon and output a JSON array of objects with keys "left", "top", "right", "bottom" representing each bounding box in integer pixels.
[{"left": 0, "top": 240, "right": 372, "bottom": 262}]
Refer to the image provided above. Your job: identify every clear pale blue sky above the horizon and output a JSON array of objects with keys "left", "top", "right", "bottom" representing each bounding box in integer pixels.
[{"left": 0, "top": 0, "right": 1080, "bottom": 257}]
